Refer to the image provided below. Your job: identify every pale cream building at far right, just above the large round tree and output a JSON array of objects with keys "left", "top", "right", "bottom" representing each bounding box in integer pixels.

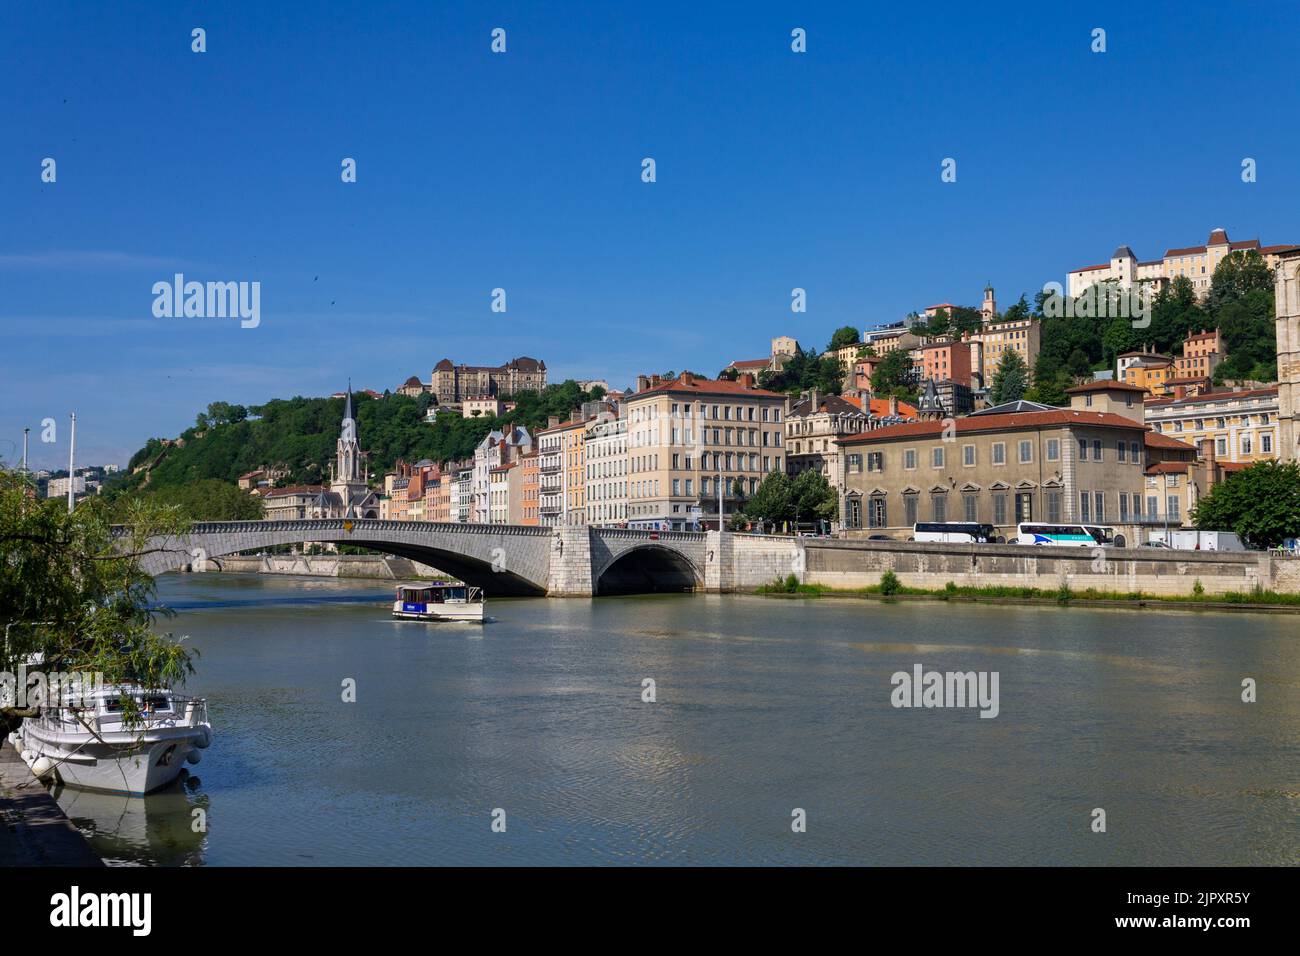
[{"left": 1147, "top": 385, "right": 1282, "bottom": 464}]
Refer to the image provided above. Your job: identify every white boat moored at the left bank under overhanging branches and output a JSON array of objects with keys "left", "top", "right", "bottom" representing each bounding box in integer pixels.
[{"left": 10, "top": 685, "right": 212, "bottom": 796}]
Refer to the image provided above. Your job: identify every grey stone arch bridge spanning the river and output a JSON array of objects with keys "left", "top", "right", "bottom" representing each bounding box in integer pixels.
[{"left": 131, "top": 518, "right": 789, "bottom": 596}]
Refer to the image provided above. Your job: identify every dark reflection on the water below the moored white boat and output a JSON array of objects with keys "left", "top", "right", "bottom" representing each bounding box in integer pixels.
[{"left": 51, "top": 771, "right": 209, "bottom": 866}]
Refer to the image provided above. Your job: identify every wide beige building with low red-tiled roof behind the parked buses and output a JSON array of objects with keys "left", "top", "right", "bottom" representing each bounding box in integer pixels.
[{"left": 840, "top": 382, "right": 1195, "bottom": 537}]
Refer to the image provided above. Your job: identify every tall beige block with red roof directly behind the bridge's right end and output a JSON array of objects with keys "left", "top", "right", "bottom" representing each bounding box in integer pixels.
[{"left": 625, "top": 372, "right": 785, "bottom": 531}]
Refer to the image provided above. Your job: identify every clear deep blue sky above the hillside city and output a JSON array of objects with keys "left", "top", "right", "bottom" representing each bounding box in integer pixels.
[{"left": 0, "top": 0, "right": 1300, "bottom": 467}]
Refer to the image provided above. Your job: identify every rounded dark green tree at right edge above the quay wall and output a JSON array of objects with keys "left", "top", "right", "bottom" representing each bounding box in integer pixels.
[{"left": 1191, "top": 462, "right": 1300, "bottom": 548}]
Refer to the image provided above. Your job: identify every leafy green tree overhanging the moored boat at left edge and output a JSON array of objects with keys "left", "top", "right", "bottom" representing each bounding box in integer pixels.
[{"left": 0, "top": 470, "right": 194, "bottom": 721}]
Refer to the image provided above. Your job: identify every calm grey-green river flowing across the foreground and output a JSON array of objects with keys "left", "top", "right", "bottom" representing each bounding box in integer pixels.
[{"left": 50, "top": 574, "right": 1300, "bottom": 865}]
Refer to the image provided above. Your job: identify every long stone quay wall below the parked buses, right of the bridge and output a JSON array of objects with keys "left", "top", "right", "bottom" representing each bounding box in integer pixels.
[{"left": 774, "top": 536, "right": 1300, "bottom": 596}]
